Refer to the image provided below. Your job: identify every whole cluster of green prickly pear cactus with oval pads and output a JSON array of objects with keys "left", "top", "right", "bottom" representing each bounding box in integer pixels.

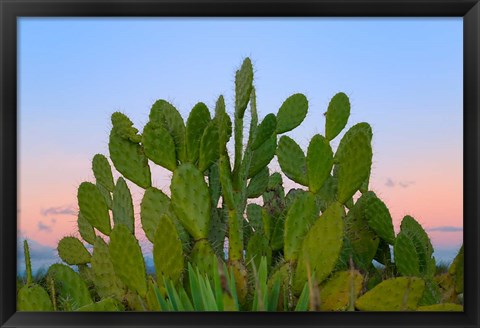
[{"left": 17, "top": 58, "right": 463, "bottom": 311}]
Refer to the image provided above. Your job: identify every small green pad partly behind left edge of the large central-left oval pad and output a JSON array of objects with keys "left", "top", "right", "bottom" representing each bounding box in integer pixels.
[{"left": 140, "top": 187, "right": 170, "bottom": 243}]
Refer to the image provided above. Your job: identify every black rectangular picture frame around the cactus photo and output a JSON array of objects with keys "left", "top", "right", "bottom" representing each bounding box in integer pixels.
[{"left": 0, "top": 0, "right": 480, "bottom": 328}]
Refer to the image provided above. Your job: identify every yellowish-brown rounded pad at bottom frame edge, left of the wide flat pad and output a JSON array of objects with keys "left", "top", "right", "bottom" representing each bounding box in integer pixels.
[{"left": 320, "top": 270, "right": 363, "bottom": 311}]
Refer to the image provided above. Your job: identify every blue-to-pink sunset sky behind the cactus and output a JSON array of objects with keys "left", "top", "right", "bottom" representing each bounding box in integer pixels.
[{"left": 17, "top": 18, "right": 463, "bottom": 271}]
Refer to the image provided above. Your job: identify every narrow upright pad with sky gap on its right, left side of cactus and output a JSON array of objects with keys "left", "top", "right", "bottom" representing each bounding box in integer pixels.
[{"left": 112, "top": 177, "right": 135, "bottom": 233}]
